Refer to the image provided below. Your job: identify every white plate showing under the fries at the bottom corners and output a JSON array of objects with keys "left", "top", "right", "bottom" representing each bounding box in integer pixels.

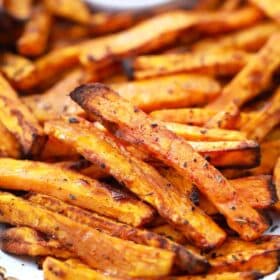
[{"left": 0, "top": 213, "right": 280, "bottom": 280}]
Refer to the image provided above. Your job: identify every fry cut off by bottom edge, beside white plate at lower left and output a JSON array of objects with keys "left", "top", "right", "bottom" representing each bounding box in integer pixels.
[{"left": 43, "top": 257, "right": 121, "bottom": 280}]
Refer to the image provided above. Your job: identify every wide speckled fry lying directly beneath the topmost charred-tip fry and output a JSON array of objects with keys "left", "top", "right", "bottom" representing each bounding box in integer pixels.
[{"left": 45, "top": 119, "right": 225, "bottom": 247}]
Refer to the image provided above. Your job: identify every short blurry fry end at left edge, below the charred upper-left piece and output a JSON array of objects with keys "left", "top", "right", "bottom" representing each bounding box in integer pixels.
[{"left": 0, "top": 53, "right": 34, "bottom": 82}]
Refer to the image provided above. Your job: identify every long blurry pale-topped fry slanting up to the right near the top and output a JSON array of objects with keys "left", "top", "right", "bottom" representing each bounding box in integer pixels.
[{"left": 80, "top": 10, "right": 198, "bottom": 67}]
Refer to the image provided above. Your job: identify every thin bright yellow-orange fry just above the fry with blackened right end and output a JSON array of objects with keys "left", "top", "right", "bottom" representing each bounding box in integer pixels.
[{"left": 162, "top": 122, "right": 246, "bottom": 141}]
